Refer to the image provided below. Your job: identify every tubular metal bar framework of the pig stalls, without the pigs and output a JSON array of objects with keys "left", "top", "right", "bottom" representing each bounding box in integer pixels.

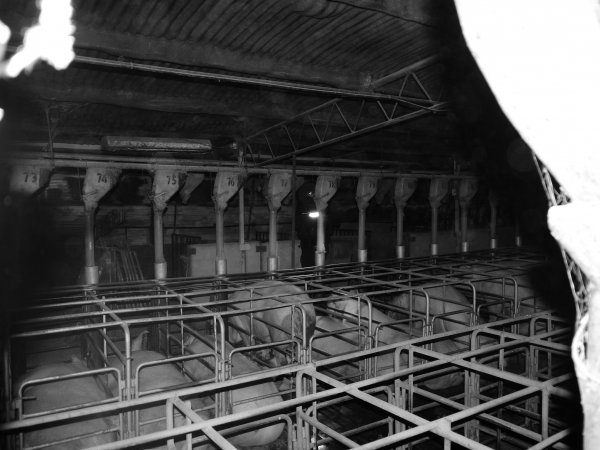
[{"left": 0, "top": 249, "right": 577, "bottom": 448}]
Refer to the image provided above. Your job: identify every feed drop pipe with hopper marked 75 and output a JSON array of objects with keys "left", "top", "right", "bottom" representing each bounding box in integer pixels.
[{"left": 150, "top": 169, "right": 186, "bottom": 280}]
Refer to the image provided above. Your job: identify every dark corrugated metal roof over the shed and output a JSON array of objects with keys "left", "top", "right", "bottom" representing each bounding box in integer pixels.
[{"left": 0, "top": 0, "right": 468, "bottom": 171}]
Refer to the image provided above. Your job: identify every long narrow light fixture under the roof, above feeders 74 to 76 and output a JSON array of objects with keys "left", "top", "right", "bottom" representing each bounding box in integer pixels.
[{"left": 102, "top": 136, "right": 212, "bottom": 153}]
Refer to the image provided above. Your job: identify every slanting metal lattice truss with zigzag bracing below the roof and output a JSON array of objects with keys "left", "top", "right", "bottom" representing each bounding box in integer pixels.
[{"left": 245, "top": 56, "right": 446, "bottom": 167}]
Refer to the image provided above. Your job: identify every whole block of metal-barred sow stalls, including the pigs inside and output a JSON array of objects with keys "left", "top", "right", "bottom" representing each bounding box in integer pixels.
[{"left": 0, "top": 249, "right": 579, "bottom": 449}]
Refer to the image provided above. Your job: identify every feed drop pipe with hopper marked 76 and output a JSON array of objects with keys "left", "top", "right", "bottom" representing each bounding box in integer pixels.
[{"left": 213, "top": 171, "right": 242, "bottom": 276}]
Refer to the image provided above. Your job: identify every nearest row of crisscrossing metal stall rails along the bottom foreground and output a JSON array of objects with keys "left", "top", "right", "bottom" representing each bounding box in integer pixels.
[{"left": 0, "top": 314, "right": 577, "bottom": 449}]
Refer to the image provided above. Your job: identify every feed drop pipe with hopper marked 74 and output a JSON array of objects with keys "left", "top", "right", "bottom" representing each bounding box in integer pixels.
[{"left": 81, "top": 167, "right": 121, "bottom": 284}]
